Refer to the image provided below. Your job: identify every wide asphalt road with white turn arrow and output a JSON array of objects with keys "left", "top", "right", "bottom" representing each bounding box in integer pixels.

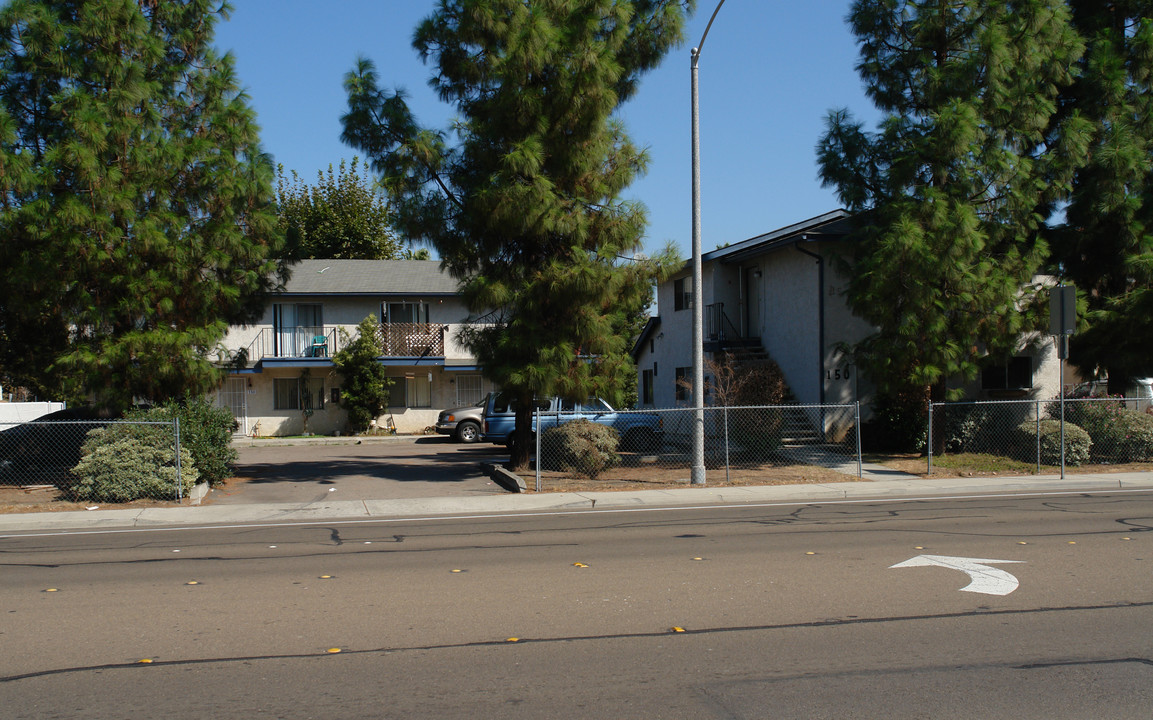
[{"left": 0, "top": 493, "right": 1153, "bottom": 719}]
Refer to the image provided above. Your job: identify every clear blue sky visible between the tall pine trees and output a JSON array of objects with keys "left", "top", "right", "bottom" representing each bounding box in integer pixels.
[{"left": 217, "top": 0, "right": 876, "bottom": 258}]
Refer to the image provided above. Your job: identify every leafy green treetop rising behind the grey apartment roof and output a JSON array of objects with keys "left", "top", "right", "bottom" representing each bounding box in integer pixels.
[{"left": 277, "top": 157, "right": 406, "bottom": 260}]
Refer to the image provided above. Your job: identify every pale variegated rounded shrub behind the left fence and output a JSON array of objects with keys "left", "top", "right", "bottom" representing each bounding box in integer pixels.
[{"left": 73, "top": 423, "right": 199, "bottom": 502}]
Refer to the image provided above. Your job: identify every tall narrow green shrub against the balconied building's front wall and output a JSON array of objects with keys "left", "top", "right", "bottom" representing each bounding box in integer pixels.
[{"left": 332, "top": 315, "right": 391, "bottom": 433}]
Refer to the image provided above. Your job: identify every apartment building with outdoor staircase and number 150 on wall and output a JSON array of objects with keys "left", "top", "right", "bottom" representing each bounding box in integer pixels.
[{"left": 633, "top": 210, "right": 1060, "bottom": 420}]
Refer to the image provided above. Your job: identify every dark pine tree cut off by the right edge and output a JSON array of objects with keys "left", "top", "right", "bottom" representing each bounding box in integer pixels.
[{"left": 1052, "top": 0, "right": 1153, "bottom": 395}]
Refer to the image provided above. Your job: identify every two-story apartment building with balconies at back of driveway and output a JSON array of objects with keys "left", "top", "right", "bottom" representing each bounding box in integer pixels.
[{"left": 220, "top": 260, "right": 491, "bottom": 436}]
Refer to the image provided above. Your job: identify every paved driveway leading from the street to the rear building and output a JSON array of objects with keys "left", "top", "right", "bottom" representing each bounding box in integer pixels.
[{"left": 212, "top": 436, "right": 508, "bottom": 504}]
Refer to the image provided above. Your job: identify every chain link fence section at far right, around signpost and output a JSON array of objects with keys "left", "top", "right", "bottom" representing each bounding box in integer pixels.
[{"left": 927, "top": 398, "right": 1153, "bottom": 474}]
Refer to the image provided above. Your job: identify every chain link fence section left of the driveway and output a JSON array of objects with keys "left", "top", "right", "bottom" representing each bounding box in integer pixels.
[{"left": 0, "top": 419, "right": 197, "bottom": 503}]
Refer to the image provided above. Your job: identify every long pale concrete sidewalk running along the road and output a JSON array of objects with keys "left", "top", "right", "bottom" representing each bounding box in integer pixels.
[{"left": 0, "top": 473, "right": 1153, "bottom": 537}]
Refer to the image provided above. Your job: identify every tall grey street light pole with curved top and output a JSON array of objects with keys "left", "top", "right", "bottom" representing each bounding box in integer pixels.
[{"left": 691, "top": 0, "right": 724, "bottom": 485}]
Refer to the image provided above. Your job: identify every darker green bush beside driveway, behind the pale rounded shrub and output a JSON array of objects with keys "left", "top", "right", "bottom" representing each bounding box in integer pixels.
[{"left": 126, "top": 396, "right": 236, "bottom": 485}]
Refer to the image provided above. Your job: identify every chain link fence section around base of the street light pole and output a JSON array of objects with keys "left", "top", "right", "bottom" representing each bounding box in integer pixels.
[{"left": 535, "top": 405, "right": 861, "bottom": 492}]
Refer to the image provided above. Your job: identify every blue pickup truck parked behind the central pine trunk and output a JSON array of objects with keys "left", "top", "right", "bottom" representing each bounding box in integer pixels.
[{"left": 481, "top": 392, "right": 664, "bottom": 451}]
